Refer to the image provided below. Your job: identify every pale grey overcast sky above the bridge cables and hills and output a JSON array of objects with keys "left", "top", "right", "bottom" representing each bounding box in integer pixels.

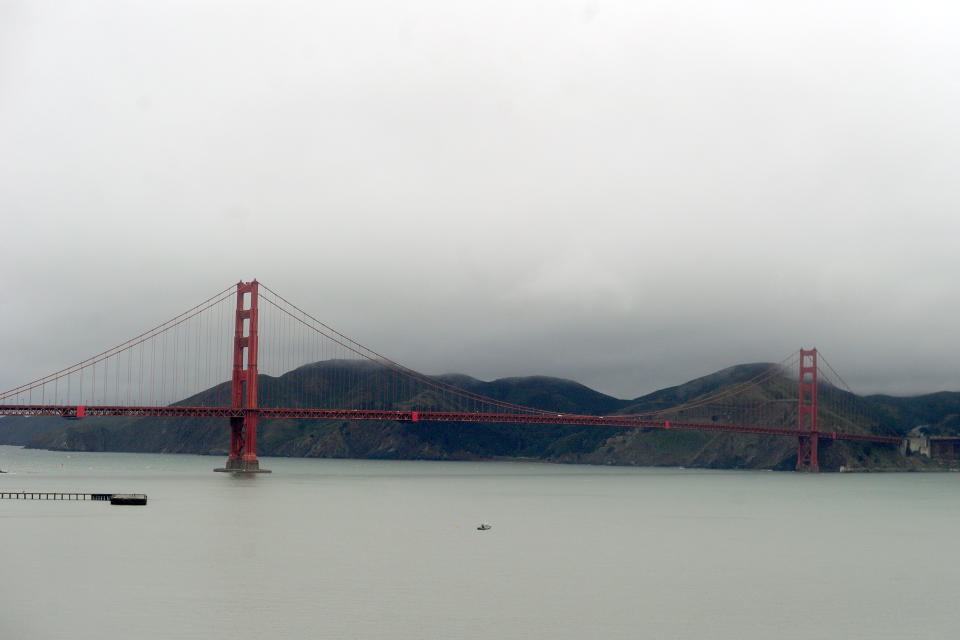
[{"left": 0, "top": 0, "right": 960, "bottom": 397}]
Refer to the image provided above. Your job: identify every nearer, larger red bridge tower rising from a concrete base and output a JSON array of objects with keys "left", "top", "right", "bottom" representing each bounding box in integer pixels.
[{"left": 214, "top": 280, "right": 270, "bottom": 473}]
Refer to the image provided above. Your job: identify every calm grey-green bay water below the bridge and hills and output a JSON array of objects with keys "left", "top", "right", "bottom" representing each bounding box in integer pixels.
[{"left": 0, "top": 447, "right": 960, "bottom": 640}]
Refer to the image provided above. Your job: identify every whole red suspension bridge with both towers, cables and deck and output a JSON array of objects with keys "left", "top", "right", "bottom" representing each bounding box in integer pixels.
[{"left": 0, "top": 280, "right": 902, "bottom": 473}]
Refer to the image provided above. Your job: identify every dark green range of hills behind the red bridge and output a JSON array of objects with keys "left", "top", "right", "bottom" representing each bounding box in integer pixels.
[{"left": 0, "top": 361, "right": 960, "bottom": 470}]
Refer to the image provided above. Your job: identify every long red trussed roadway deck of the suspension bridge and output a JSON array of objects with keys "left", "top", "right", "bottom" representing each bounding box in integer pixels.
[{"left": 0, "top": 405, "right": 903, "bottom": 444}]
